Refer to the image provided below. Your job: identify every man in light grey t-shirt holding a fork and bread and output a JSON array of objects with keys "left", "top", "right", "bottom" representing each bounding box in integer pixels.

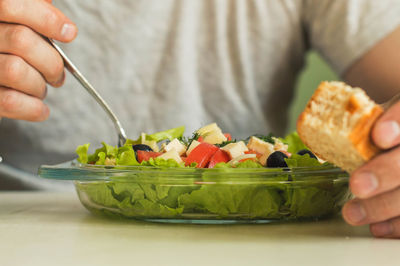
[{"left": 0, "top": 0, "right": 400, "bottom": 237}]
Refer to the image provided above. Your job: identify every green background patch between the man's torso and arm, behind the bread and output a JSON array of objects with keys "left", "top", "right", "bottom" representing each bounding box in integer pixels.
[{"left": 287, "top": 52, "right": 339, "bottom": 133}]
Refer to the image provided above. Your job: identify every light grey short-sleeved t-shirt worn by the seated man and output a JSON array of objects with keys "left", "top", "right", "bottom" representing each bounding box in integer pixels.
[{"left": 0, "top": 0, "right": 400, "bottom": 188}]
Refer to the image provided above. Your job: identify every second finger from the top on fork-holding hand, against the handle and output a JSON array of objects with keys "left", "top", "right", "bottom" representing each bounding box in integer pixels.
[{"left": 0, "top": 23, "right": 64, "bottom": 87}]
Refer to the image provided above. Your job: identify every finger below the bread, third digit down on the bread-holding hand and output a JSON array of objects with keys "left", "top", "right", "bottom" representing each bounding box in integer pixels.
[{"left": 342, "top": 189, "right": 400, "bottom": 225}]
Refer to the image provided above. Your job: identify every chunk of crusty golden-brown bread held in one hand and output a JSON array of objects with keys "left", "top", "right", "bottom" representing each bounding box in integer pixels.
[{"left": 297, "top": 82, "right": 383, "bottom": 173}]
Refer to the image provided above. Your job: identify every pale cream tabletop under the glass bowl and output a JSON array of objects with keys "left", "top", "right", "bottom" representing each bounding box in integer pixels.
[{"left": 0, "top": 192, "right": 400, "bottom": 266}]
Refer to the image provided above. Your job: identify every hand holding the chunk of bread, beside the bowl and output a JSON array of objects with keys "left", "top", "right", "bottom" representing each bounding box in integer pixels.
[{"left": 343, "top": 102, "right": 400, "bottom": 238}]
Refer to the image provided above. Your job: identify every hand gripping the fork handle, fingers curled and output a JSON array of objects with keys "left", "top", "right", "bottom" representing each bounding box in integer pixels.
[{"left": 0, "top": 0, "right": 77, "bottom": 121}]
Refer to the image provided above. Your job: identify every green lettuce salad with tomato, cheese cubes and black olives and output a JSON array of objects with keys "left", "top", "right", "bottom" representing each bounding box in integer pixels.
[{"left": 76, "top": 124, "right": 348, "bottom": 220}]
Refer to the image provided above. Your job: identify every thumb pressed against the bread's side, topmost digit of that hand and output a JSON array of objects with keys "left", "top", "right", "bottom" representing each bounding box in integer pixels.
[{"left": 372, "top": 102, "right": 400, "bottom": 149}]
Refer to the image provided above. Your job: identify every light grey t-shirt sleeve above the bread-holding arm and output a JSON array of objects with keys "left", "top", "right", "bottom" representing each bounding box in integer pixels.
[{"left": 303, "top": 0, "right": 400, "bottom": 75}]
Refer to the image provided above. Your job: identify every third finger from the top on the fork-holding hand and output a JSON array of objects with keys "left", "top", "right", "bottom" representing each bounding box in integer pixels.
[{"left": 0, "top": 54, "right": 46, "bottom": 99}]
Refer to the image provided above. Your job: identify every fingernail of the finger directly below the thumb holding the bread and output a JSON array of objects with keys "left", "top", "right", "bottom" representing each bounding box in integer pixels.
[{"left": 351, "top": 172, "right": 378, "bottom": 198}]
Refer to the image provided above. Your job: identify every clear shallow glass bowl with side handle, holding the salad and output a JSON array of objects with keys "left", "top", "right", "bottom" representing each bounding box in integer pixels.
[{"left": 39, "top": 161, "right": 350, "bottom": 223}]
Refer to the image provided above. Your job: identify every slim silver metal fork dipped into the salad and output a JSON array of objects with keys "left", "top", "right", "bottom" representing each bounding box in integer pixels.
[{"left": 47, "top": 38, "right": 127, "bottom": 147}]
